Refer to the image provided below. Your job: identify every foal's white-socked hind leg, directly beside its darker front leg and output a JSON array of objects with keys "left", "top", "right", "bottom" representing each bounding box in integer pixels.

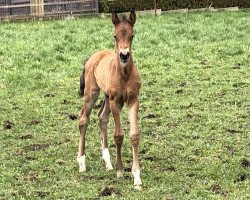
[{"left": 98, "top": 97, "right": 113, "bottom": 170}]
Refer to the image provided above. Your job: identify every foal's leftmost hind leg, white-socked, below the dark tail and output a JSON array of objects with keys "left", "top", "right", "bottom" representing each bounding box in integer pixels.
[{"left": 77, "top": 88, "right": 100, "bottom": 172}]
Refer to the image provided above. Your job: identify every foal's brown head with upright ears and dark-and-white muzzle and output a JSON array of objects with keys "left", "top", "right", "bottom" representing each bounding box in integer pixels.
[{"left": 112, "top": 11, "right": 136, "bottom": 65}]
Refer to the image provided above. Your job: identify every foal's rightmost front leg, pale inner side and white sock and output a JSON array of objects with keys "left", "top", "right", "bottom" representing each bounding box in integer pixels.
[{"left": 128, "top": 98, "right": 142, "bottom": 189}]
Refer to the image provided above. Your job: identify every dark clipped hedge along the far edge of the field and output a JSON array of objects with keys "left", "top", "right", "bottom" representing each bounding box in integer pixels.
[{"left": 99, "top": 0, "right": 250, "bottom": 12}]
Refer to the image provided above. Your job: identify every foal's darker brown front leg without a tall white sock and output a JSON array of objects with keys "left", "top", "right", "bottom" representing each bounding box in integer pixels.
[{"left": 110, "top": 98, "right": 124, "bottom": 178}]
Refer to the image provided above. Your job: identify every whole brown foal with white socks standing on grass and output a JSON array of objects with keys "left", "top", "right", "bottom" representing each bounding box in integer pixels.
[{"left": 77, "top": 11, "right": 142, "bottom": 187}]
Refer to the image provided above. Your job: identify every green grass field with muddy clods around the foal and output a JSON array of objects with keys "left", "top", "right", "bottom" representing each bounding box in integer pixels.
[{"left": 0, "top": 10, "right": 250, "bottom": 199}]
